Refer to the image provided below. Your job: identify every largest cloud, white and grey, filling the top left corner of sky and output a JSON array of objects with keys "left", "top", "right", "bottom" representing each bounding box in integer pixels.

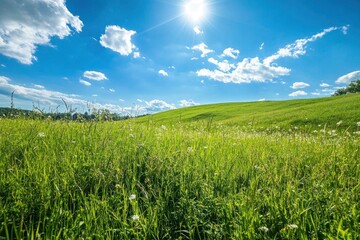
[{"left": 0, "top": 0, "right": 83, "bottom": 64}]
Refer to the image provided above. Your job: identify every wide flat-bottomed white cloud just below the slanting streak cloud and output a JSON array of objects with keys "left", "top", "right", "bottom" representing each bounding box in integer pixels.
[{"left": 196, "top": 57, "right": 291, "bottom": 83}]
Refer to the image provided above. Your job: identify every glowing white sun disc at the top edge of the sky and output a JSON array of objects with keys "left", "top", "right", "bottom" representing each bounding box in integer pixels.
[{"left": 184, "top": 0, "right": 208, "bottom": 23}]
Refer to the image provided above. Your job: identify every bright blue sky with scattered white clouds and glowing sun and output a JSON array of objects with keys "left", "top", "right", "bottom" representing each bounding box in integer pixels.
[{"left": 0, "top": 0, "right": 360, "bottom": 114}]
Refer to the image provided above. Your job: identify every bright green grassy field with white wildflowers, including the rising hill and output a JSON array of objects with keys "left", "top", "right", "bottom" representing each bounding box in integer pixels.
[{"left": 0, "top": 95, "right": 360, "bottom": 239}]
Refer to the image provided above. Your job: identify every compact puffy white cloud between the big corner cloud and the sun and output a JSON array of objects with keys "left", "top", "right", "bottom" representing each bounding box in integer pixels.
[{"left": 100, "top": 25, "right": 136, "bottom": 56}]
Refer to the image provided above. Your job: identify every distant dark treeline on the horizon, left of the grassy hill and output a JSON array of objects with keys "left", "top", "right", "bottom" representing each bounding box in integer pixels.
[{"left": 0, "top": 108, "right": 143, "bottom": 121}]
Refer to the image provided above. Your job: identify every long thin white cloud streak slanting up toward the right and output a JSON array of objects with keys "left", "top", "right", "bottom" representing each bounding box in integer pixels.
[{"left": 264, "top": 27, "right": 341, "bottom": 65}]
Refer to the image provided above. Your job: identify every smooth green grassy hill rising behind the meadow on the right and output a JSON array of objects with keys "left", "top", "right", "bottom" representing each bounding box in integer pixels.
[{"left": 138, "top": 94, "right": 360, "bottom": 128}]
